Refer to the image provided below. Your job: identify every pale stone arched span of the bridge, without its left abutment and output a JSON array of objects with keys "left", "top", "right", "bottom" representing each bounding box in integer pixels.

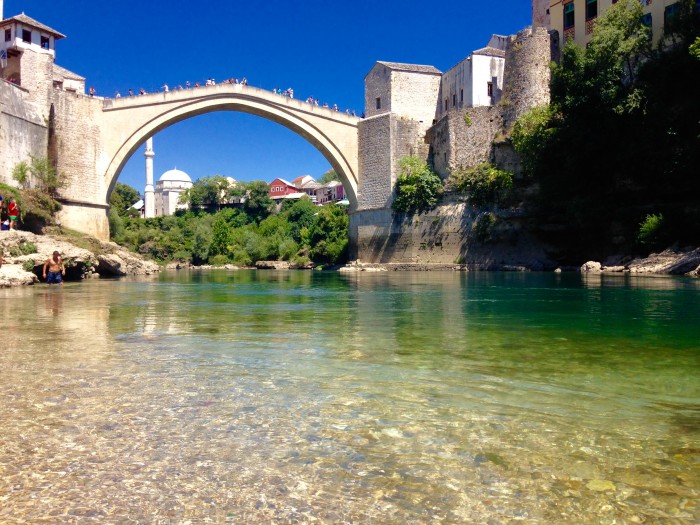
[{"left": 98, "top": 84, "right": 359, "bottom": 207}]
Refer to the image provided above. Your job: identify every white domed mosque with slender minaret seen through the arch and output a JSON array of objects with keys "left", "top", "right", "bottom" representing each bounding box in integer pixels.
[{"left": 143, "top": 138, "right": 192, "bottom": 218}]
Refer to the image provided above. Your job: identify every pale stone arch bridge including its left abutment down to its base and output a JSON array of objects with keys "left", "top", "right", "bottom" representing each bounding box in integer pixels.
[{"left": 56, "top": 84, "right": 360, "bottom": 239}]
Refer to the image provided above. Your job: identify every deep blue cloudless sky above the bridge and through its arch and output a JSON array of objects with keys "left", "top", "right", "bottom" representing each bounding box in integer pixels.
[{"left": 4, "top": 0, "right": 531, "bottom": 192}]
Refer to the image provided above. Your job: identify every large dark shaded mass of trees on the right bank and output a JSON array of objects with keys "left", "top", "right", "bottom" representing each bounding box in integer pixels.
[{"left": 512, "top": 0, "right": 700, "bottom": 259}]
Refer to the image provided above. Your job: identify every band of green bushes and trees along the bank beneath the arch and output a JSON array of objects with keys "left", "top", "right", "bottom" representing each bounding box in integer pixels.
[{"left": 112, "top": 190, "right": 349, "bottom": 266}]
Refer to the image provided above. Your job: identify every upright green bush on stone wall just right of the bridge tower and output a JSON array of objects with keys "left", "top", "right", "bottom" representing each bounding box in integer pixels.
[{"left": 393, "top": 156, "right": 442, "bottom": 213}]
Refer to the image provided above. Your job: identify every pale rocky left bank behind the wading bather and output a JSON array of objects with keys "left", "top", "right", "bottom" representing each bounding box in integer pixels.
[{"left": 0, "top": 230, "right": 160, "bottom": 288}]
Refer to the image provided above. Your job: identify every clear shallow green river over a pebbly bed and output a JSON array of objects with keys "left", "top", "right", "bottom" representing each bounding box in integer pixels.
[{"left": 0, "top": 271, "right": 700, "bottom": 524}]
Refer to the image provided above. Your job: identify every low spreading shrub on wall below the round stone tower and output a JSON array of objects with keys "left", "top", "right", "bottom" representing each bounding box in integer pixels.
[{"left": 450, "top": 163, "right": 513, "bottom": 206}]
